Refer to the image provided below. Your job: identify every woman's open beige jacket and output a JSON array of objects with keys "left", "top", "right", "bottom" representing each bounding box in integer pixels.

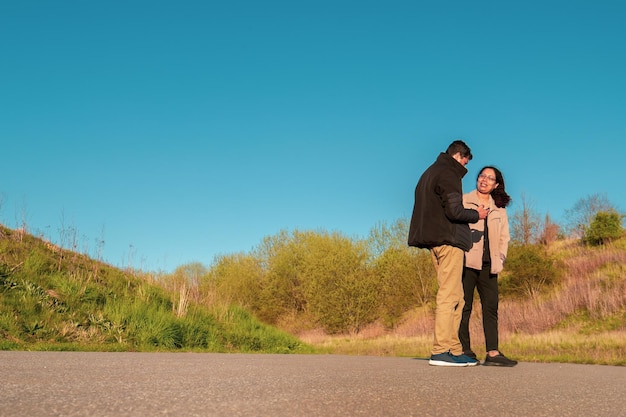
[{"left": 463, "top": 190, "right": 511, "bottom": 274}]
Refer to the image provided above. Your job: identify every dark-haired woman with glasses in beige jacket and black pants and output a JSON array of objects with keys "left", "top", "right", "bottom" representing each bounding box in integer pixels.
[{"left": 459, "top": 166, "right": 517, "bottom": 366}]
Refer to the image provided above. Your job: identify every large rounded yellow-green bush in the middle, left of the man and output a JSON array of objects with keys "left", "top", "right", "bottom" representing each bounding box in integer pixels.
[{"left": 249, "top": 231, "right": 380, "bottom": 333}]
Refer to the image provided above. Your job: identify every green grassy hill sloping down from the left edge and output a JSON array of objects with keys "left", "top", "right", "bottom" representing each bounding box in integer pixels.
[{"left": 0, "top": 226, "right": 311, "bottom": 353}]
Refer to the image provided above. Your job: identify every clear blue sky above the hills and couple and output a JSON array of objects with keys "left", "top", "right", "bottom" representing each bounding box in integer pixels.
[{"left": 0, "top": 0, "right": 626, "bottom": 271}]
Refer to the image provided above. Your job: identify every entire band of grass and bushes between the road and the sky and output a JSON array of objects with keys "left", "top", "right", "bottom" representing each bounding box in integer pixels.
[{"left": 0, "top": 196, "right": 626, "bottom": 365}]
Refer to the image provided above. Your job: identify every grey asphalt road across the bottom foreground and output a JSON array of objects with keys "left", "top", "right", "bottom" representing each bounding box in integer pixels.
[{"left": 0, "top": 351, "right": 626, "bottom": 417}]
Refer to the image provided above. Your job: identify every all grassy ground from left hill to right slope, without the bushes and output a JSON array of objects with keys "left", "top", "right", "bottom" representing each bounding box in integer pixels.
[{"left": 0, "top": 226, "right": 626, "bottom": 365}]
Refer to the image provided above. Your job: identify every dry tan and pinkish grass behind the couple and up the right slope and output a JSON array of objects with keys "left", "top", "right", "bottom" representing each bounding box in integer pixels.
[{"left": 300, "top": 237, "right": 626, "bottom": 365}]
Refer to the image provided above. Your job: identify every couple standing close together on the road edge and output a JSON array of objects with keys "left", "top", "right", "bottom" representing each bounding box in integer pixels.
[{"left": 408, "top": 140, "right": 517, "bottom": 367}]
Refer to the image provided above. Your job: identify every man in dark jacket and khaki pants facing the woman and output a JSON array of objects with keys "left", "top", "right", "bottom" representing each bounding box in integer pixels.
[{"left": 408, "top": 140, "right": 488, "bottom": 366}]
